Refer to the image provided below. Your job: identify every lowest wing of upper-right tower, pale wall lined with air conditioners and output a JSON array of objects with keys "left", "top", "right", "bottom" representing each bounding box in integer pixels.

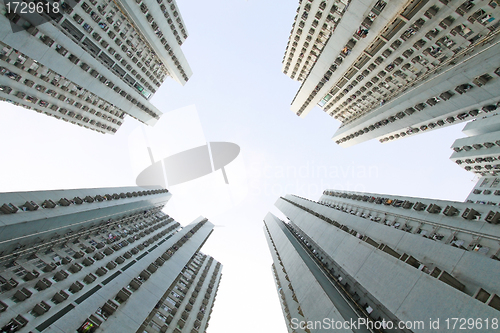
[{"left": 333, "top": 44, "right": 500, "bottom": 147}]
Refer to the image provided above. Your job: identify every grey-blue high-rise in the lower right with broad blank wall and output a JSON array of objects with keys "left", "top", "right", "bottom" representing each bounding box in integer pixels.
[{"left": 264, "top": 190, "right": 500, "bottom": 332}]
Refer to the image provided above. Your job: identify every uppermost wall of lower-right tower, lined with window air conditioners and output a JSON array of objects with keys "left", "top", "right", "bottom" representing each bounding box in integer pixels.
[{"left": 320, "top": 190, "right": 500, "bottom": 262}]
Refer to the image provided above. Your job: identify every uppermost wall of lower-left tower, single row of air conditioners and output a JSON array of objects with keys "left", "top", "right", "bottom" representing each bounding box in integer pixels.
[{"left": 0, "top": 187, "right": 171, "bottom": 254}]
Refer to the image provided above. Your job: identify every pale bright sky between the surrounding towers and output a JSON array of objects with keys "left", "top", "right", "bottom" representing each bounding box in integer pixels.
[{"left": 0, "top": 0, "right": 475, "bottom": 333}]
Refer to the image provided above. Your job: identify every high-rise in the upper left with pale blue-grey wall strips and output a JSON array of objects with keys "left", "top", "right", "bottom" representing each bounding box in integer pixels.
[{"left": 0, "top": 0, "right": 192, "bottom": 133}]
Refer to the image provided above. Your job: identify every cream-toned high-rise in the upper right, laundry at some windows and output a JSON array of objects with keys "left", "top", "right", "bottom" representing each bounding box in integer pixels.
[{"left": 283, "top": 0, "right": 500, "bottom": 147}]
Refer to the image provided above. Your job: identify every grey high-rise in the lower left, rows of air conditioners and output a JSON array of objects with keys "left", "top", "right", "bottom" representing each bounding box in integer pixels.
[{"left": 0, "top": 187, "right": 221, "bottom": 333}]
